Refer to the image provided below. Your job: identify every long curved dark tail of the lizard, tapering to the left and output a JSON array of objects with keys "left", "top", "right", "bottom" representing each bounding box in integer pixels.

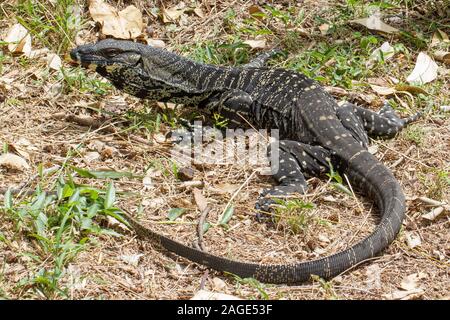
[{"left": 125, "top": 149, "right": 405, "bottom": 283}]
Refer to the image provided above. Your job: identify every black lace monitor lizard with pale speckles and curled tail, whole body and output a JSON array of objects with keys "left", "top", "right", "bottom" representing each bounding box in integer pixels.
[{"left": 71, "top": 39, "right": 419, "bottom": 283}]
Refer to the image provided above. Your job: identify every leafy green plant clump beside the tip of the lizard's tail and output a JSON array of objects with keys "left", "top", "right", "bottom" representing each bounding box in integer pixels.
[{"left": 0, "top": 174, "right": 123, "bottom": 298}]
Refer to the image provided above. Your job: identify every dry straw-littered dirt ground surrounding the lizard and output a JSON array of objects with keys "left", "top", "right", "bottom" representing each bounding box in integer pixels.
[{"left": 0, "top": 0, "right": 450, "bottom": 299}]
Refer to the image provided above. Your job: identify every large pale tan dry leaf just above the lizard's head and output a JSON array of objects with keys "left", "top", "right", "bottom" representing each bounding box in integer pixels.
[{"left": 89, "top": 0, "right": 144, "bottom": 39}]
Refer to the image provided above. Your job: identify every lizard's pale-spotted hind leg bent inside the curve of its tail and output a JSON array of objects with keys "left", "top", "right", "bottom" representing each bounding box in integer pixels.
[{"left": 255, "top": 140, "right": 330, "bottom": 220}]
